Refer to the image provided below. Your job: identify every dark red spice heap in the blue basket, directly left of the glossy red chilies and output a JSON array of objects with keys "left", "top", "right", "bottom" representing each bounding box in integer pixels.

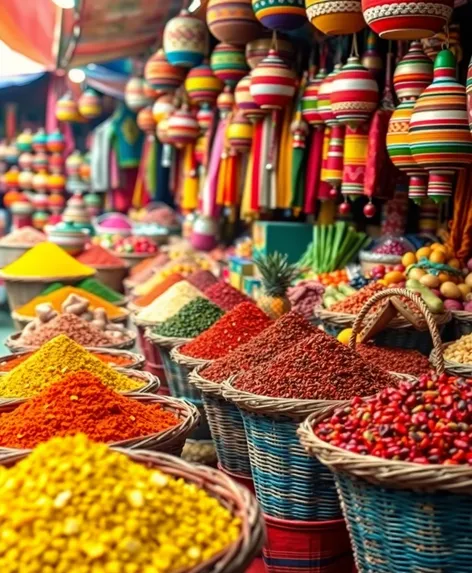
[{"left": 235, "top": 330, "right": 396, "bottom": 400}]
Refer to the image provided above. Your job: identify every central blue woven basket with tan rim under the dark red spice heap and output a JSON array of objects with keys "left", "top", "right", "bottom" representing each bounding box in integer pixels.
[{"left": 223, "top": 380, "right": 341, "bottom": 521}]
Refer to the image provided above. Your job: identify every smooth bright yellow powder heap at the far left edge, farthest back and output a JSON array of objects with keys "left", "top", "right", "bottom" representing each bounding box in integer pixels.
[{"left": 3, "top": 243, "right": 95, "bottom": 278}]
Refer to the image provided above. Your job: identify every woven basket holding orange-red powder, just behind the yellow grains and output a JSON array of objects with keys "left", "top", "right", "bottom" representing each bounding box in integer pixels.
[{"left": 0, "top": 393, "right": 200, "bottom": 456}]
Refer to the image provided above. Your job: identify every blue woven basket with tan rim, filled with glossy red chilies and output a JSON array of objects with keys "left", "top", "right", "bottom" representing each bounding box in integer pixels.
[{"left": 299, "top": 409, "right": 472, "bottom": 573}]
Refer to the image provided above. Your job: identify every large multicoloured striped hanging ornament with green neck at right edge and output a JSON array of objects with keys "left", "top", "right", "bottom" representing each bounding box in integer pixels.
[{"left": 409, "top": 50, "right": 472, "bottom": 201}]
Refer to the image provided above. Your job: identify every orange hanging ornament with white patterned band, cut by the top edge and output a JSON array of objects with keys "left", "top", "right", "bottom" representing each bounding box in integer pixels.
[{"left": 305, "top": 0, "right": 365, "bottom": 36}]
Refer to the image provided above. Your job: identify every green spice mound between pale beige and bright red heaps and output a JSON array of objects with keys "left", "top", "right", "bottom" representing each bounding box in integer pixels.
[{"left": 153, "top": 297, "right": 224, "bottom": 338}]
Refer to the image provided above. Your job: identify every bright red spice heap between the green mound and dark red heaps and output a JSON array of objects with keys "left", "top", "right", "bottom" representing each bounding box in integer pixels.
[{"left": 180, "top": 302, "right": 272, "bottom": 360}]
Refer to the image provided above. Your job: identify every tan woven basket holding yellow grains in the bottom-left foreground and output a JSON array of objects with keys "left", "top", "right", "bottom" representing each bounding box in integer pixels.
[{"left": 0, "top": 448, "right": 265, "bottom": 573}]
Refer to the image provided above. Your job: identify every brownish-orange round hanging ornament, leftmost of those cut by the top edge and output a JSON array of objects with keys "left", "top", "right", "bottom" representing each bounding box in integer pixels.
[{"left": 206, "top": 0, "right": 261, "bottom": 45}]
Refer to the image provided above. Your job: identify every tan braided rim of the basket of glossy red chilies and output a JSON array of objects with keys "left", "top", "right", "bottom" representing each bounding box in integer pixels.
[{"left": 297, "top": 406, "right": 472, "bottom": 494}]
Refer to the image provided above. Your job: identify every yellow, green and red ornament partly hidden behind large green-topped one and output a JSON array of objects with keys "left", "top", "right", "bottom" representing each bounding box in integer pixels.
[{"left": 387, "top": 99, "right": 428, "bottom": 203}]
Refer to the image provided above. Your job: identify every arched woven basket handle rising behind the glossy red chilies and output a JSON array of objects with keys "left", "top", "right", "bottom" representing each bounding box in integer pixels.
[{"left": 349, "top": 288, "right": 444, "bottom": 374}]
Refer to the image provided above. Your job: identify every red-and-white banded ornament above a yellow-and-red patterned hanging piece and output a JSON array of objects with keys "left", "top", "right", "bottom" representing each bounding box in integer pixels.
[{"left": 331, "top": 56, "right": 379, "bottom": 127}]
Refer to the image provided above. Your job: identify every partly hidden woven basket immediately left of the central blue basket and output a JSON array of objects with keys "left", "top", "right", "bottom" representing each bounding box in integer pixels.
[{"left": 189, "top": 365, "right": 252, "bottom": 478}]
